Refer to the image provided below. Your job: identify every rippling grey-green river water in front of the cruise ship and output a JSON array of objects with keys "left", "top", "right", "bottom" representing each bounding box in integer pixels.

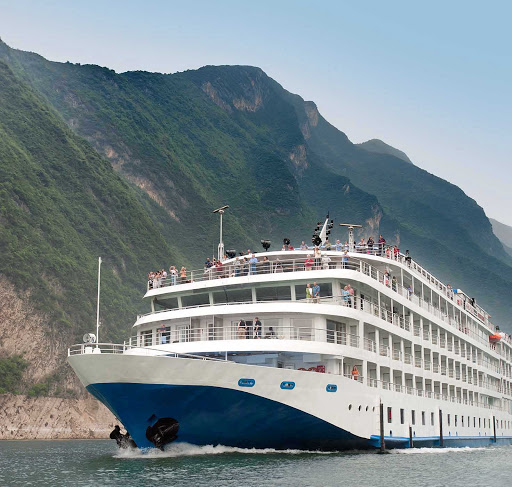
[{"left": 0, "top": 440, "right": 512, "bottom": 487}]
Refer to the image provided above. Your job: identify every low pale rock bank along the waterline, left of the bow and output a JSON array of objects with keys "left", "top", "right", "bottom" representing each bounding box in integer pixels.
[{"left": 0, "top": 394, "right": 119, "bottom": 440}]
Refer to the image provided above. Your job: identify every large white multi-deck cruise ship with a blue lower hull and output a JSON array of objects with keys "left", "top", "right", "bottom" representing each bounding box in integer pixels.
[{"left": 68, "top": 214, "right": 512, "bottom": 451}]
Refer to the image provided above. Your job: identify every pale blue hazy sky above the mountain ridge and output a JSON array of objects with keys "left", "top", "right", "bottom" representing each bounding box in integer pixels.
[{"left": 0, "top": 0, "right": 512, "bottom": 225}]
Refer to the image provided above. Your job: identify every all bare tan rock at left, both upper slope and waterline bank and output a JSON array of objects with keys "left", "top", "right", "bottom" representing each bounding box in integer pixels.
[{"left": 0, "top": 277, "right": 116, "bottom": 440}]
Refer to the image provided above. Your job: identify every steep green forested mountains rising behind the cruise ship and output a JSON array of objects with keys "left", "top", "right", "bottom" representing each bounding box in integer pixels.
[{"left": 0, "top": 42, "right": 512, "bottom": 400}]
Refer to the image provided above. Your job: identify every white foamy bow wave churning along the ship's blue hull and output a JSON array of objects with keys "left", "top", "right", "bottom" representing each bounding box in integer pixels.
[{"left": 114, "top": 443, "right": 338, "bottom": 459}]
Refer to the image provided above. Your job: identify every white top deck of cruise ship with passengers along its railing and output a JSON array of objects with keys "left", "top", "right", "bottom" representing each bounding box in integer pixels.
[{"left": 143, "top": 249, "right": 512, "bottom": 345}]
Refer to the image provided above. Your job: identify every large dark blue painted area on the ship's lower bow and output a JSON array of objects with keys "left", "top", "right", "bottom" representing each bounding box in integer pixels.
[{"left": 87, "top": 383, "right": 370, "bottom": 450}]
